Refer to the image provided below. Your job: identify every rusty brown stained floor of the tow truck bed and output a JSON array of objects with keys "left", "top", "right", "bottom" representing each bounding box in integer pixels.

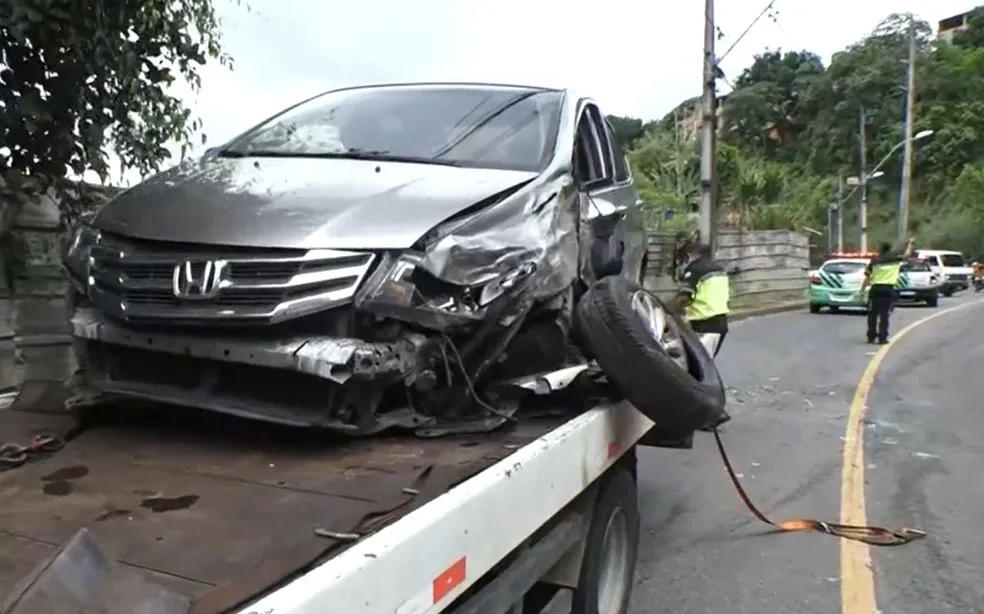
[{"left": 0, "top": 382, "right": 563, "bottom": 614}]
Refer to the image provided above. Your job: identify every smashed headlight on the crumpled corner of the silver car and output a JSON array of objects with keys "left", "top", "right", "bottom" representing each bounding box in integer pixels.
[{"left": 355, "top": 252, "right": 533, "bottom": 330}]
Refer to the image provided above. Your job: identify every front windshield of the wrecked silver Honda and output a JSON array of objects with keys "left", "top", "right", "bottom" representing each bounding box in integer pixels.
[{"left": 223, "top": 86, "right": 563, "bottom": 171}]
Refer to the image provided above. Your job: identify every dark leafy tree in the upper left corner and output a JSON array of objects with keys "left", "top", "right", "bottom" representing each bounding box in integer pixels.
[{"left": 0, "top": 0, "right": 230, "bottom": 220}]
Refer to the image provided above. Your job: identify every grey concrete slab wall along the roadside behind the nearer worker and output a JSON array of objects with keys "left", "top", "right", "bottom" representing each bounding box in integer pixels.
[{"left": 646, "top": 230, "right": 810, "bottom": 311}]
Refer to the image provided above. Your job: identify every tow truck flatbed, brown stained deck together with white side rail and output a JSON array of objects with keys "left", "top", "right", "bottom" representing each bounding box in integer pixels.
[{"left": 0, "top": 382, "right": 652, "bottom": 614}]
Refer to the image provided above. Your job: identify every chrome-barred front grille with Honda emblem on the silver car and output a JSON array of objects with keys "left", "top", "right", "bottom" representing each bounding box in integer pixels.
[{"left": 88, "top": 237, "right": 374, "bottom": 324}]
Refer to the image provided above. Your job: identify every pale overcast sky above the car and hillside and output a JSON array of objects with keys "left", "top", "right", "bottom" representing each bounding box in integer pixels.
[{"left": 102, "top": 0, "right": 976, "bottom": 184}]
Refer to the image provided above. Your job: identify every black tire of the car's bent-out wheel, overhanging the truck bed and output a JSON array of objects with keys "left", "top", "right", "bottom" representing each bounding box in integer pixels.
[{"left": 575, "top": 277, "right": 727, "bottom": 437}]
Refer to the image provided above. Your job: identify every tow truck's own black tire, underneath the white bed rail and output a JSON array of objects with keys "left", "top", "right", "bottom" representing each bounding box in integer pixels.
[{"left": 571, "top": 465, "right": 639, "bottom": 614}]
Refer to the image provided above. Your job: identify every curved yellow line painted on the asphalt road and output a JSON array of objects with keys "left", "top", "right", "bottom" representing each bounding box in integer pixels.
[{"left": 840, "top": 301, "right": 982, "bottom": 614}]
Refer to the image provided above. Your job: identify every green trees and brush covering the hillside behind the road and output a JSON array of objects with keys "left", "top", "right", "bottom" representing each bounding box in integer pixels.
[{"left": 613, "top": 6, "right": 984, "bottom": 256}]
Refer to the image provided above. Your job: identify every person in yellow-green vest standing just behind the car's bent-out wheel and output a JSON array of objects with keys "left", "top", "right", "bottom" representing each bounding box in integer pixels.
[{"left": 680, "top": 243, "right": 731, "bottom": 356}]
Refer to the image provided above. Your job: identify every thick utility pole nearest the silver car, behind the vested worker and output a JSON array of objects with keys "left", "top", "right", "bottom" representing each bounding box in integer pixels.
[{"left": 699, "top": 0, "right": 717, "bottom": 249}]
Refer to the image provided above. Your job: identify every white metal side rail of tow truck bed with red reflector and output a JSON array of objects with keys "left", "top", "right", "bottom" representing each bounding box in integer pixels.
[{"left": 238, "top": 404, "right": 653, "bottom": 614}]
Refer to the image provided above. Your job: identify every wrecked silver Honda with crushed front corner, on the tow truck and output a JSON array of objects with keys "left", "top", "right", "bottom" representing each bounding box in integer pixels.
[{"left": 64, "top": 84, "right": 723, "bottom": 435}]
